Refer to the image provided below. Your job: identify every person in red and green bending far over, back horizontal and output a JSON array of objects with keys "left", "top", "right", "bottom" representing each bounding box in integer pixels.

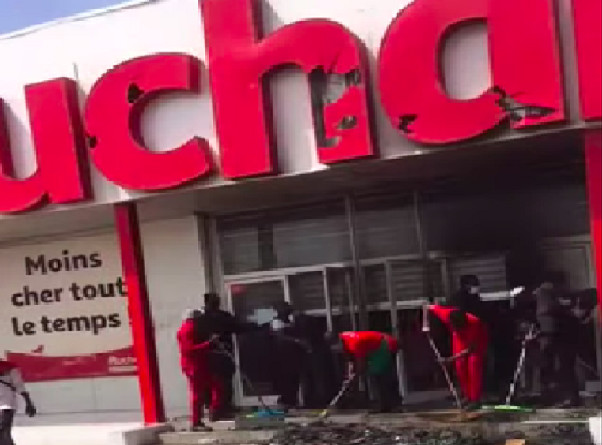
[{"left": 331, "top": 331, "right": 400, "bottom": 412}]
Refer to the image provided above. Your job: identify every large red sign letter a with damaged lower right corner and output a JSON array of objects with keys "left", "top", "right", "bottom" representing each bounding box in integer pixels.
[{"left": 379, "top": 0, "right": 564, "bottom": 144}]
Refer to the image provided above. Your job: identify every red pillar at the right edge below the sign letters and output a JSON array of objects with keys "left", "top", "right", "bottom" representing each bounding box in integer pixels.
[{"left": 584, "top": 128, "right": 602, "bottom": 315}]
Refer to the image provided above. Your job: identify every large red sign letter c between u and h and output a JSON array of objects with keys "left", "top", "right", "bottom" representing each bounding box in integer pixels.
[{"left": 85, "top": 54, "right": 211, "bottom": 191}]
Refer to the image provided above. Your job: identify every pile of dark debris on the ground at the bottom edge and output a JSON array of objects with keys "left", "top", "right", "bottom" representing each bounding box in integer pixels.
[{"left": 270, "top": 423, "right": 493, "bottom": 445}]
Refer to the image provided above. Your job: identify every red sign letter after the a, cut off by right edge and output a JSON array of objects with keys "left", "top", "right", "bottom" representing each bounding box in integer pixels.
[{"left": 573, "top": 0, "right": 602, "bottom": 120}]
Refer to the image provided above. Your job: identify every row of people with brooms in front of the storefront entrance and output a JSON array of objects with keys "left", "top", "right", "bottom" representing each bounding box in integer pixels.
[{"left": 177, "top": 272, "right": 596, "bottom": 429}]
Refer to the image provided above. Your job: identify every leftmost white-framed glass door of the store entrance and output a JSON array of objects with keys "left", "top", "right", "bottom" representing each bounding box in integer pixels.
[{"left": 227, "top": 276, "right": 289, "bottom": 406}]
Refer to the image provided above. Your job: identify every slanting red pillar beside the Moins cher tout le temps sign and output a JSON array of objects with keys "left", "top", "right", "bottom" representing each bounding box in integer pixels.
[{"left": 115, "top": 203, "right": 165, "bottom": 424}]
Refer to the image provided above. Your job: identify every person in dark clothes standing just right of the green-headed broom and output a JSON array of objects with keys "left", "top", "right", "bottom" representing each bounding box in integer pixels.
[{"left": 535, "top": 272, "right": 579, "bottom": 406}]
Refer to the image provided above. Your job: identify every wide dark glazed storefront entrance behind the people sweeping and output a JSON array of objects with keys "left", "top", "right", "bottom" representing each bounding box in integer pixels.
[{"left": 214, "top": 154, "right": 601, "bottom": 404}]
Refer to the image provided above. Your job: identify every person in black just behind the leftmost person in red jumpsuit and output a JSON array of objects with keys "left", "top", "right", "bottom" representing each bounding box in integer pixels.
[{"left": 197, "top": 292, "right": 254, "bottom": 421}]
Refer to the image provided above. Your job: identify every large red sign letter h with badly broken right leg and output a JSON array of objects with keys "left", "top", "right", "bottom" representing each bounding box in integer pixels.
[{"left": 202, "top": 0, "right": 373, "bottom": 178}]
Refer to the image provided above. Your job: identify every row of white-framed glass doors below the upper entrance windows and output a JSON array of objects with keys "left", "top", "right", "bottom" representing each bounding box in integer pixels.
[{"left": 226, "top": 260, "right": 446, "bottom": 405}]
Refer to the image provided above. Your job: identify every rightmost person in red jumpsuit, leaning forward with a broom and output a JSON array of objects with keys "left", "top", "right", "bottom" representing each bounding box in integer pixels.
[{"left": 429, "top": 305, "right": 488, "bottom": 408}]
